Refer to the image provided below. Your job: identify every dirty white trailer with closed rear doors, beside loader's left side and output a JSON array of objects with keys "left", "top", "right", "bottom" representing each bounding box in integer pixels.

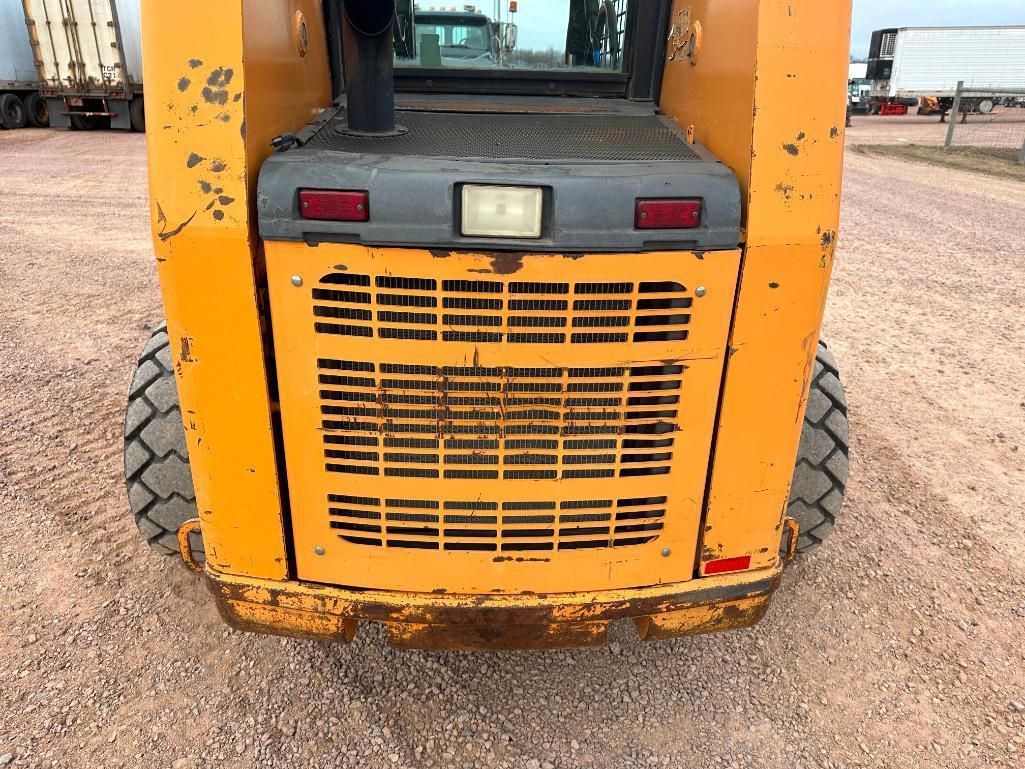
[{"left": 22, "top": 0, "right": 146, "bottom": 131}]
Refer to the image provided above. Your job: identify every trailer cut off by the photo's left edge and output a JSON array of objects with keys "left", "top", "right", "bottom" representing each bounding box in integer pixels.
[{"left": 0, "top": 0, "right": 47, "bottom": 128}]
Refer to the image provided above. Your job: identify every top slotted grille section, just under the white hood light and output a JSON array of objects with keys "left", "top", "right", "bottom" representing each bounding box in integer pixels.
[{"left": 313, "top": 273, "right": 693, "bottom": 345}]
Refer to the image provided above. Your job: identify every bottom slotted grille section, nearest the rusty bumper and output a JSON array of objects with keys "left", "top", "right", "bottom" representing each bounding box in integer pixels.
[{"left": 327, "top": 494, "right": 666, "bottom": 553}]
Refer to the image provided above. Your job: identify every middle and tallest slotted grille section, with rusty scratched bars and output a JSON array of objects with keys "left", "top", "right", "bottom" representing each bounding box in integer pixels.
[{"left": 318, "top": 359, "right": 684, "bottom": 480}]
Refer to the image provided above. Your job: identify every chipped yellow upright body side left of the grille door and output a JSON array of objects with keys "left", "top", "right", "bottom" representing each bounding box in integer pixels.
[{"left": 142, "top": 0, "right": 330, "bottom": 578}]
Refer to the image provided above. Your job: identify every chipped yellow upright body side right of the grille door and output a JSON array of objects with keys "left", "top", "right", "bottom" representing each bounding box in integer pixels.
[{"left": 663, "top": 0, "right": 851, "bottom": 568}]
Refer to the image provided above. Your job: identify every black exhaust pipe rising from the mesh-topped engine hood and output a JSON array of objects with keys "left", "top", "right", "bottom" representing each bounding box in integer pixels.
[{"left": 341, "top": 0, "right": 399, "bottom": 136}]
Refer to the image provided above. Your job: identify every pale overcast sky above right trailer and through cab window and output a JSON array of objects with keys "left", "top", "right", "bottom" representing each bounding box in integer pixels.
[{"left": 492, "top": 0, "right": 1025, "bottom": 56}]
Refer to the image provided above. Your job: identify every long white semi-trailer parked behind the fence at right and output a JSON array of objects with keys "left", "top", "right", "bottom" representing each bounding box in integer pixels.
[{"left": 867, "top": 26, "right": 1025, "bottom": 115}]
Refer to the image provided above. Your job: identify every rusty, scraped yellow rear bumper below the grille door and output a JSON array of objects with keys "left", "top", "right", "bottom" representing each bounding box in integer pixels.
[{"left": 204, "top": 563, "right": 782, "bottom": 650}]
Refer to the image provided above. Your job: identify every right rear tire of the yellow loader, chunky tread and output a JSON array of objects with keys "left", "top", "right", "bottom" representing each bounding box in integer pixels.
[{"left": 780, "top": 342, "right": 851, "bottom": 553}]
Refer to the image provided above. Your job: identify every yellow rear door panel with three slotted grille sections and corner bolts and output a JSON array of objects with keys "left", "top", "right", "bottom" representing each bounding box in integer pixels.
[{"left": 265, "top": 242, "right": 739, "bottom": 593}]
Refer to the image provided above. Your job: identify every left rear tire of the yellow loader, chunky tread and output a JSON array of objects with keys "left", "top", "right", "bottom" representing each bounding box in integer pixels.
[{"left": 125, "top": 325, "right": 204, "bottom": 562}]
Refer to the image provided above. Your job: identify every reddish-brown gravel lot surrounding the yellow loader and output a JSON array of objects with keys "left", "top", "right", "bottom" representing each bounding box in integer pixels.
[{"left": 0, "top": 119, "right": 1025, "bottom": 769}]
